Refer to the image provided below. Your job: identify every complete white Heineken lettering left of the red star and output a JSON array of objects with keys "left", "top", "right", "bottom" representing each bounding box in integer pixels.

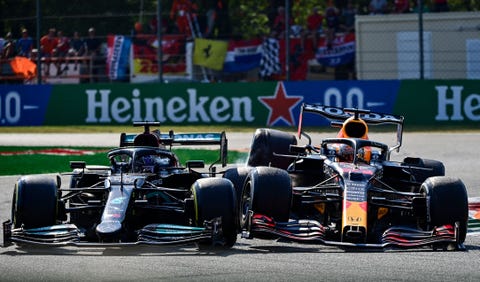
[{"left": 85, "top": 88, "right": 255, "bottom": 123}]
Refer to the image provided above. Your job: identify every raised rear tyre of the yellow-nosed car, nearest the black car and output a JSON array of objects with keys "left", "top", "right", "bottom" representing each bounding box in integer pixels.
[{"left": 247, "top": 128, "right": 297, "bottom": 169}]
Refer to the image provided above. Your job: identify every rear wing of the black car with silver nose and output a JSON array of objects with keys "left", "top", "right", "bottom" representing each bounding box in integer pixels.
[{"left": 120, "top": 122, "right": 228, "bottom": 167}]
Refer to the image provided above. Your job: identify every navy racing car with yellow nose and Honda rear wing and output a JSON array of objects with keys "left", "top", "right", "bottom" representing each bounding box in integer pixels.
[{"left": 233, "top": 104, "right": 468, "bottom": 249}]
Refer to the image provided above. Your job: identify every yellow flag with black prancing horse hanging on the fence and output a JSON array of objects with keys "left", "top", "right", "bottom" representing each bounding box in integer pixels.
[{"left": 193, "top": 38, "right": 228, "bottom": 70}]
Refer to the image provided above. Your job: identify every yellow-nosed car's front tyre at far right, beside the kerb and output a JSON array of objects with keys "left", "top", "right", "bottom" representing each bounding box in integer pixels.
[{"left": 421, "top": 176, "right": 468, "bottom": 243}]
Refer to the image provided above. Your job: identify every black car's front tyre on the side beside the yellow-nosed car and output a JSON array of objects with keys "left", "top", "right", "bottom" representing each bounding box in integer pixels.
[{"left": 192, "top": 177, "right": 237, "bottom": 247}]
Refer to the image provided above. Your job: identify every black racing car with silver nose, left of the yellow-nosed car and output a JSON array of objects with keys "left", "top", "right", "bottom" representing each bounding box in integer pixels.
[{"left": 3, "top": 122, "right": 238, "bottom": 247}]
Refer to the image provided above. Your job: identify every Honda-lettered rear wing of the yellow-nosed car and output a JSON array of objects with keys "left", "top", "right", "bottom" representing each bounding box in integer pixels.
[{"left": 298, "top": 103, "right": 404, "bottom": 151}]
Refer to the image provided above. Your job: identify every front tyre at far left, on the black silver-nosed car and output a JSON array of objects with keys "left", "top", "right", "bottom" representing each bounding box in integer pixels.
[{"left": 12, "top": 175, "right": 58, "bottom": 229}]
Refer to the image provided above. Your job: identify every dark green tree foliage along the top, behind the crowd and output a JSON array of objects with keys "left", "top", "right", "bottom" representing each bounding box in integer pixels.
[{"left": 0, "top": 0, "right": 480, "bottom": 38}]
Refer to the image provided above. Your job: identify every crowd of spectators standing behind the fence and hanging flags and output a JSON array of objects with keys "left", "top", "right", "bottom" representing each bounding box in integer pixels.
[{"left": 0, "top": 0, "right": 468, "bottom": 82}]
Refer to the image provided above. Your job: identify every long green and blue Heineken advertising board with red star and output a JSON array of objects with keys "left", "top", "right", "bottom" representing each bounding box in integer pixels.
[{"left": 0, "top": 80, "right": 480, "bottom": 128}]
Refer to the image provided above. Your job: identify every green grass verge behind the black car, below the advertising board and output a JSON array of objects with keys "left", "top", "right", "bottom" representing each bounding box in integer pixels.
[{"left": 0, "top": 146, "right": 247, "bottom": 175}]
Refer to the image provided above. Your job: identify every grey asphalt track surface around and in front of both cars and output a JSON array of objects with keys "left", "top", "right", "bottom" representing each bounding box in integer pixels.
[{"left": 0, "top": 132, "right": 480, "bottom": 281}]
